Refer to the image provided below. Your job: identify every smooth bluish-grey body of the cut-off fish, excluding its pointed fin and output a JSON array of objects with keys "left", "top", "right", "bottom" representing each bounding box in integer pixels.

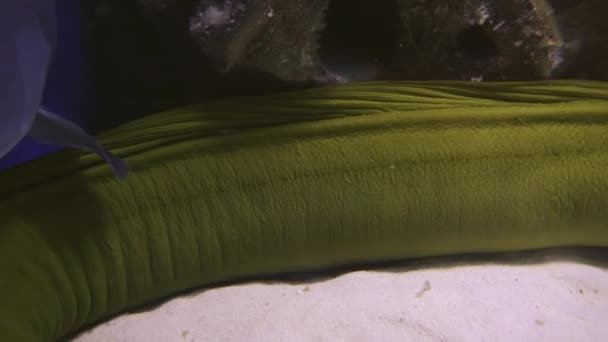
[{"left": 0, "top": 0, "right": 56, "bottom": 158}]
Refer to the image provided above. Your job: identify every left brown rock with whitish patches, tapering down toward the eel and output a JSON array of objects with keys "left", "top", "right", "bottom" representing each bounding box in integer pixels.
[{"left": 190, "top": 0, "right": 331, "bottom": 83}]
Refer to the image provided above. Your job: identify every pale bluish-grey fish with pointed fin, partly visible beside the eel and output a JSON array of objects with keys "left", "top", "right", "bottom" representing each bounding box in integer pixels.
[{"left": 0, "top": 0, "right": 128, "bottom": 179}]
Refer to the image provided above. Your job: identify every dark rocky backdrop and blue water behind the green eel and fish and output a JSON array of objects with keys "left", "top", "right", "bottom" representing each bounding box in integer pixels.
[{"left": 0, "top": 0, "right": 608, "bottom": 169}]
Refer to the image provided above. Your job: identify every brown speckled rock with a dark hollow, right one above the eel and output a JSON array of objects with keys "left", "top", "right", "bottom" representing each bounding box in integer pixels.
[{"left": 399, "top": 0, "right": 564, "bottom": 80}]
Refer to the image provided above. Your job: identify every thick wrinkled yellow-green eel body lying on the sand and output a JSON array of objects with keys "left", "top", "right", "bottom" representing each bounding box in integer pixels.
[{"left": 0, "top": 81, "right": 608, "bottom": 341}]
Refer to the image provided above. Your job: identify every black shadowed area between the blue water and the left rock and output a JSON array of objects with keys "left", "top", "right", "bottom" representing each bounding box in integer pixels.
[{"left": 84, "top": 0, "right": 306, "bottom": 133}]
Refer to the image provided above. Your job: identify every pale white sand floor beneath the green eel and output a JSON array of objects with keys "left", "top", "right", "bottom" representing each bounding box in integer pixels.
[{"left": 75, "top": 248, "right": 608, "bottom": 342}]
